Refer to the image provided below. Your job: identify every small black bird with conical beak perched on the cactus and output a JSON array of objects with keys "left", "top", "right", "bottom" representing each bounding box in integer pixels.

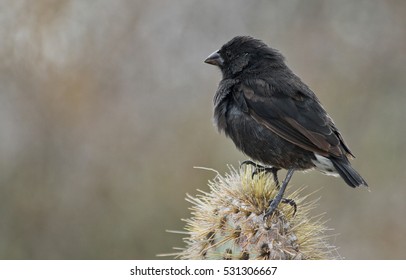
[{"left": 204, "top": 36, "right": 367, "bottom": 217}]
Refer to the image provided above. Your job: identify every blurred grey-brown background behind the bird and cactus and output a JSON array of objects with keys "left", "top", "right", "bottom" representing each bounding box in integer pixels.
[{"left": 0, "top": 0, "right": 406, "bottom": 259}]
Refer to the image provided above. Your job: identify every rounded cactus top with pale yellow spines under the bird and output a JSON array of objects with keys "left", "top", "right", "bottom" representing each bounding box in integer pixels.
[{"left": 174, "top": 166, "right": 339, "bottom": 260}]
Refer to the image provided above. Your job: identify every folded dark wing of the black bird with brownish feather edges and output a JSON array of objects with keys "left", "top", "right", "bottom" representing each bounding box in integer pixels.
[{"left": 238, "top": 79, "right": 352, "bottom": 157}]
